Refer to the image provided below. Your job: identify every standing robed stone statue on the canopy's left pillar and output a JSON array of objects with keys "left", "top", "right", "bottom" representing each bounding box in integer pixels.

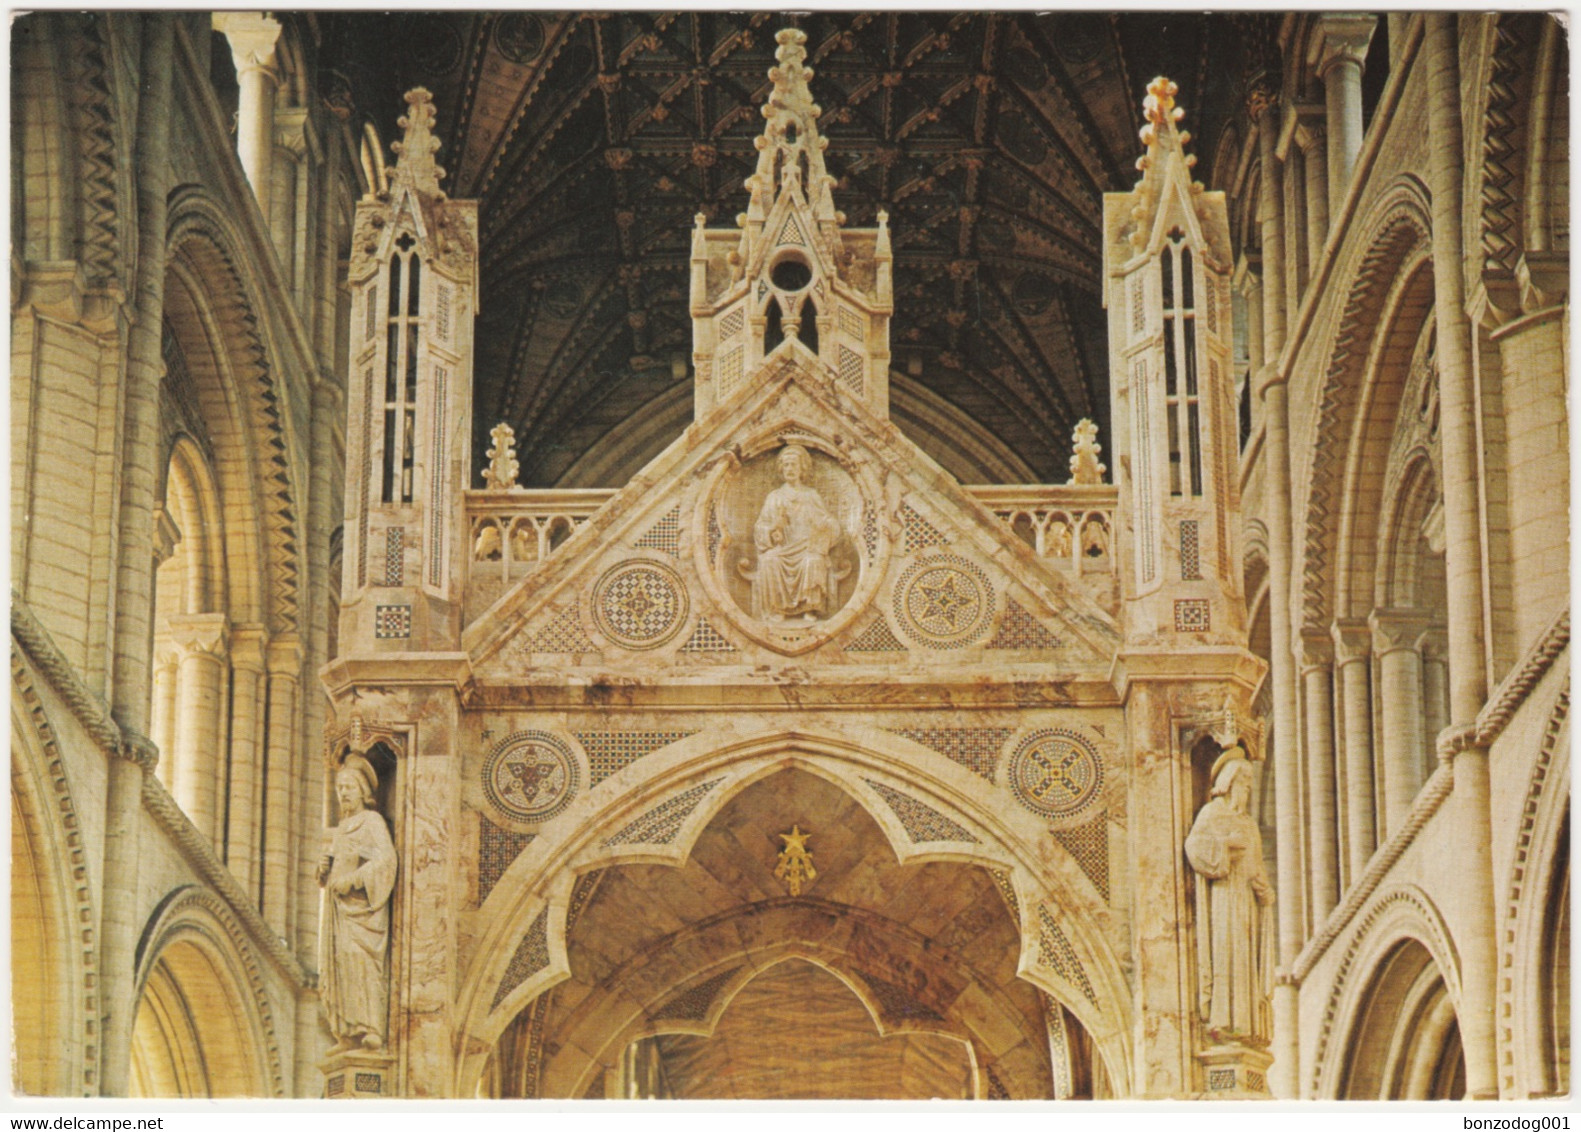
[{"left": 318, "top": 754, "right": 395, "bottom": 1053}]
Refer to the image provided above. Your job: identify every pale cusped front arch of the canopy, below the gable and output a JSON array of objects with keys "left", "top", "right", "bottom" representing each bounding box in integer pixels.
[{"left": 457, "top": 729, "right": 1130, "bottom": 1091}]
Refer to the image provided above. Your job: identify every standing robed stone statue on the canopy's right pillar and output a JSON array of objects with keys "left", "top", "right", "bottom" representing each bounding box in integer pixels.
[{"left": 1186, "top": 743, "right": 1274, "bottom": 1042}]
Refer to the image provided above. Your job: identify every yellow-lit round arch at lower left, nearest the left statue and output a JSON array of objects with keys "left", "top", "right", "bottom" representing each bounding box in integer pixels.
[{"left": 131, "top": 885, "right": 285, "bottom": 1097}]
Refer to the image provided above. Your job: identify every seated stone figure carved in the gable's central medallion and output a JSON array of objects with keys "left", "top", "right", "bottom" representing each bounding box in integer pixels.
[{"left": 743, "top": 444, "right": 841, "bottom": 621}]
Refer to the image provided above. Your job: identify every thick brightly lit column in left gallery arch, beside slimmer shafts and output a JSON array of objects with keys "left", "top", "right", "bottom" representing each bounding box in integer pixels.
[{"left": 171, "top": 613, "right": 229, "bottom": 849}]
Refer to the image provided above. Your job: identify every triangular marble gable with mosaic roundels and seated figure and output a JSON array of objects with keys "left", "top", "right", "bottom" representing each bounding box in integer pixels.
[{"left": 463, "top": 354, "right": 1118, "bottom": 683}]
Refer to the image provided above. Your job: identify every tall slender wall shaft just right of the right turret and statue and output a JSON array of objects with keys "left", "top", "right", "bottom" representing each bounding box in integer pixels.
[{"left": 1247, "top": 84, "right": 1303, "bottom": 1099}]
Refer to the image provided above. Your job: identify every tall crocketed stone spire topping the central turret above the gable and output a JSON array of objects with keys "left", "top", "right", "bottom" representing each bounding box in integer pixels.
[{"left": 745, "top": 27, "right": 836, "bottom": 221}]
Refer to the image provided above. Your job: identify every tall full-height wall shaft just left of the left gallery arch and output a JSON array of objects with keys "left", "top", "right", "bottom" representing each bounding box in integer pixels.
[{"left": 98, "top": 13, "right": 175, "bottom": 1097}]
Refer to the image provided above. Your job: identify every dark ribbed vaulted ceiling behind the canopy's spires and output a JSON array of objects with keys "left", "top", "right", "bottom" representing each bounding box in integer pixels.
[{"left": 321, "top": 11, "right": 1273, "bottom": 487}]
